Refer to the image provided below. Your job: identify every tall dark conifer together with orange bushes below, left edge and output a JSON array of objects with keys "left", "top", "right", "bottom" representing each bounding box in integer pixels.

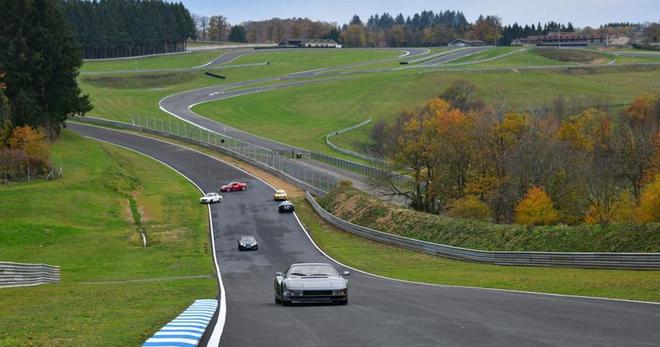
[{"left": 0, "top": 0, "right": 91, "bottom": 181}]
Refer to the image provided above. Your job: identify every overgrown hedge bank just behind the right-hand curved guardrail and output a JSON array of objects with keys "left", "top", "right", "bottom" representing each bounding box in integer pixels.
[{"left": 319, "top": 186, "right": 660, "bottom": 252}]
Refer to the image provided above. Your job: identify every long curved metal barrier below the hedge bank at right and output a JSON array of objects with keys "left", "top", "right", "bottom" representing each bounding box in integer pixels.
[{"left": 306, "top": 192, "right": 660, "bottom": 270}]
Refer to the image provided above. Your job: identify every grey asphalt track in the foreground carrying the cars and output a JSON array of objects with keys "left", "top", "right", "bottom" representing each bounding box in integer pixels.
[{"left": 69, "top": 124, "right": 660, "bottom": 346}]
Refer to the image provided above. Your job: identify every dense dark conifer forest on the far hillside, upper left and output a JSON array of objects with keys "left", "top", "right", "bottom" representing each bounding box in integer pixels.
[{"left": 60, "top": 0, "right": 196, "bottom": 58}]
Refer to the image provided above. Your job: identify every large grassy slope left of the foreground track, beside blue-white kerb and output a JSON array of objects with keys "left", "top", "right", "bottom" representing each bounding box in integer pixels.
[{"left": 0, "top": 131, "right": 217, "bottom": 346}]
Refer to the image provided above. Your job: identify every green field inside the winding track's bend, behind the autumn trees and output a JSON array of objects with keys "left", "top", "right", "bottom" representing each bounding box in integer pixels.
[{"left": 194, "top": 66, "right": 660, "bottom": 153}]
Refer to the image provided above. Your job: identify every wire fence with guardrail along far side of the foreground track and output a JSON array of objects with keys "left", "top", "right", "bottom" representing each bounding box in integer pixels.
[{"left": 74, "top": 117, "right": 337, "bottom": 196}]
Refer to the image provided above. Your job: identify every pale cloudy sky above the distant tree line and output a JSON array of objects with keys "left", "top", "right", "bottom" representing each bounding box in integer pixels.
[{"left": 178, "top": 0, "right": 660, "bottom": 27}]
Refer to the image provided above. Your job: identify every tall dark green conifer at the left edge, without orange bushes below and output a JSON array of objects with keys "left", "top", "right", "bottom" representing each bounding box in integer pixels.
[{"left": 0, "top": 0, "right": 91, "bottom": 136}]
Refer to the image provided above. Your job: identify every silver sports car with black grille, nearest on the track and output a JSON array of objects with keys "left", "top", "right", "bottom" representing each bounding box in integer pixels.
[{"left": 274, "top": 263, "right": 349, "bottom": 306}]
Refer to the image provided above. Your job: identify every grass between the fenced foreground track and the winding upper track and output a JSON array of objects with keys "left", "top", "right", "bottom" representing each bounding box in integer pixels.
[{"left": 79, "top": 49, "right": 401, "bottom": 125}]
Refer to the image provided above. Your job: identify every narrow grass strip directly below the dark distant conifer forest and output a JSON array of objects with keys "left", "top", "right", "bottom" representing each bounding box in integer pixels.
[{"left": 81, "top": 50, "right": 223, "bottom": 73}]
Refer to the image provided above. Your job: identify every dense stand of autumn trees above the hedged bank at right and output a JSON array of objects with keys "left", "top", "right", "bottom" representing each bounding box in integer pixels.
[{"left": 372, "top": 81, "right": 660, "bottom": 225}]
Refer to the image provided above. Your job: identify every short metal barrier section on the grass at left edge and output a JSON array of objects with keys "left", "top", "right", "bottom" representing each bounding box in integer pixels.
[{"left": 0, "top": 262, "right": 60, "bottom": 288}]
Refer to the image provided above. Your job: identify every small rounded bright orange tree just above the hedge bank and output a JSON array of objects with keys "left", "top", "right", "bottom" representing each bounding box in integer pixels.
[{"left": 516, "top": 187, "right": 559, "bottom": 225}]
